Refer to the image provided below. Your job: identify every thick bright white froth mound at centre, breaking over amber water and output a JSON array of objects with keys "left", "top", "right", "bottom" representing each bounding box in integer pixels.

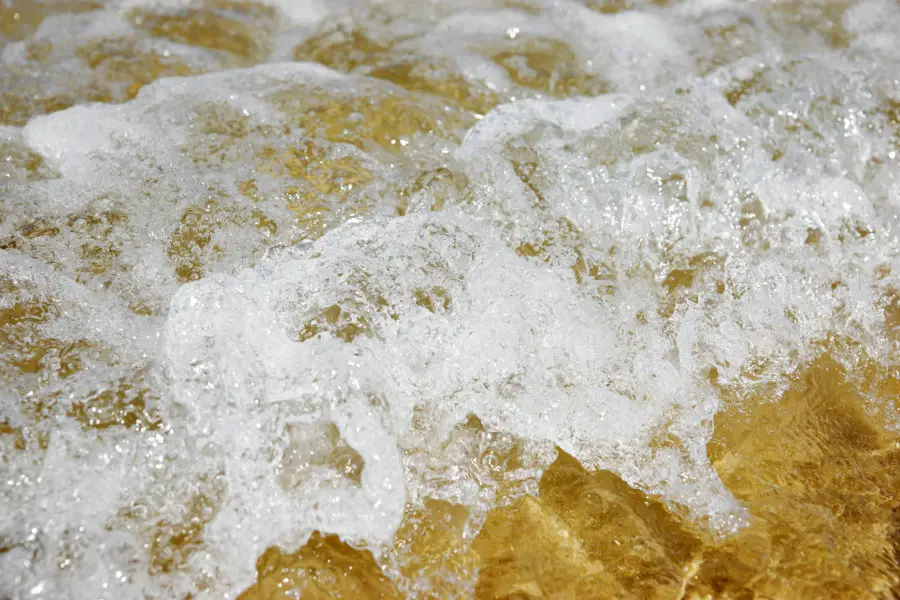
[{"left": 165, "top": 217, "right": 740, "bottom": 550}]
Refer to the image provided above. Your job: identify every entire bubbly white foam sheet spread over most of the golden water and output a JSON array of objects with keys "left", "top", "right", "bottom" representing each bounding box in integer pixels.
[{"left": 0, "top": 0, "right": 900, "bottom": 599}]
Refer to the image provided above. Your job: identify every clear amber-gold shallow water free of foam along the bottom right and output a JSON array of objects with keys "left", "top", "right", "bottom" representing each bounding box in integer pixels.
[{"left": 242, "top": 358, "right": 900, "bottom": 600}]
